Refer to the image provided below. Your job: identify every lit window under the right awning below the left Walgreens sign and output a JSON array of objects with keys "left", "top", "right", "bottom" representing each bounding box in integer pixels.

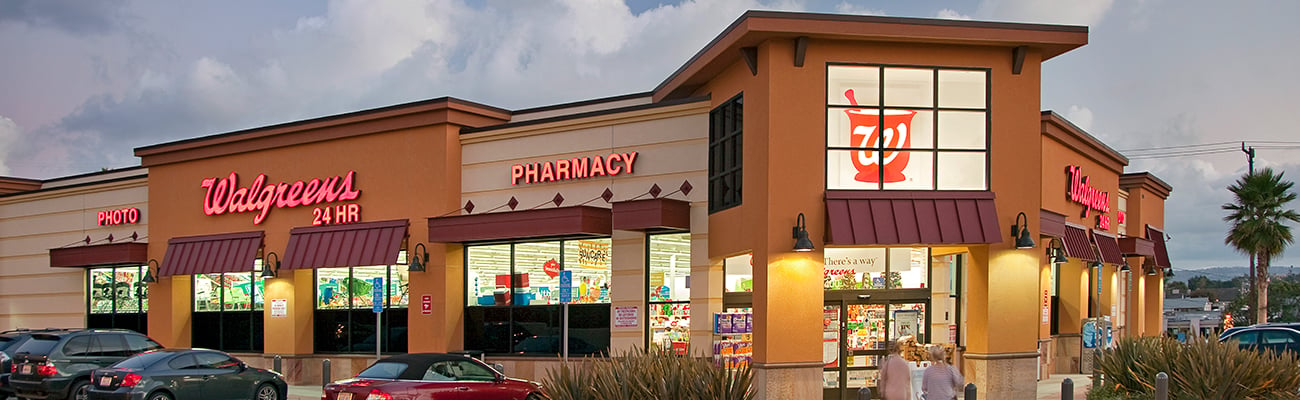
[{"left": 315, "top": 251, "right": 411, "bottom": 353}]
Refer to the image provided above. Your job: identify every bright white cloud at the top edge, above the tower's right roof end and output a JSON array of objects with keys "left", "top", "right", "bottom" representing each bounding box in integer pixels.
[{"left": 975, "top": 0, "right": 1114, "bottom": 26}]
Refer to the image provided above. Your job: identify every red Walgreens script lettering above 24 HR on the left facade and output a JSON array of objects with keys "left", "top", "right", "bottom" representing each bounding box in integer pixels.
[{"left": 199, "top": 170, "right": 361, "bottom": 225}]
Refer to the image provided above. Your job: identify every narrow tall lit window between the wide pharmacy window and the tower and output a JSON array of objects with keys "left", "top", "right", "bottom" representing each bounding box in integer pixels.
[{"left": 646, "top": 232, "right": 690, "bottom": 353}]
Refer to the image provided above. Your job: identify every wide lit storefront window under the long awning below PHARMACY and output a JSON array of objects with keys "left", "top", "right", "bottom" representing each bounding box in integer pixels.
[{"left": 465, "top": 238, "right": 611, "bottom": 355}]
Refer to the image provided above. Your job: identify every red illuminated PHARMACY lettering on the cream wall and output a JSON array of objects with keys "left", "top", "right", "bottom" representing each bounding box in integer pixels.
[{"left": 510, "top": 152, "right": 637, "bottom": 184}]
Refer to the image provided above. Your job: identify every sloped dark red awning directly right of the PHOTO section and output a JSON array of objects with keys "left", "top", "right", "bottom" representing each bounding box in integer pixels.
[{"left": 159, "top": 231, "right": 265, "bottom": 277}]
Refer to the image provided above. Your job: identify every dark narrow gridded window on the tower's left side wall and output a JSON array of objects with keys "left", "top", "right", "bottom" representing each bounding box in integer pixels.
[{"left": 709, "top": 94, "right": 745, "bottom": 213}]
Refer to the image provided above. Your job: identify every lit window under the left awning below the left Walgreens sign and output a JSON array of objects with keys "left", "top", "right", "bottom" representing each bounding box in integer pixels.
[{"left": 190, "top": 257, "right": 265, "bottom": 352}]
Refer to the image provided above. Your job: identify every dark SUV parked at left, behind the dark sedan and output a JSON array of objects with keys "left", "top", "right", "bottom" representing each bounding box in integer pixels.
[{"left": 9, "top": 329, "right": 163, "bottom": 400}]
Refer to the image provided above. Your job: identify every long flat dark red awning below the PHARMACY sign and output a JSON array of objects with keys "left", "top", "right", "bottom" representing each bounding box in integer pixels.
[{"left": 429, "top": 205, "right": 612, "bottom": 243}]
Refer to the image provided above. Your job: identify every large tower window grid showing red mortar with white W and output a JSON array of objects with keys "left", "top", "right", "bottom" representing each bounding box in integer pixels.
[{"left": 826, "top": 64, "right": 991, "bottom": 190}]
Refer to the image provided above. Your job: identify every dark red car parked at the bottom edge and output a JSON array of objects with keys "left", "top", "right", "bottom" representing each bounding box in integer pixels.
[{"left": 321, "top": 353, "right": 547, "bottom": 400}]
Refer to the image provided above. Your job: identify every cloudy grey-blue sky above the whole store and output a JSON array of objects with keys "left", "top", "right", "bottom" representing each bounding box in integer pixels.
[{"left": 0, "top": 0, "right": 1300, "bottom": 269}]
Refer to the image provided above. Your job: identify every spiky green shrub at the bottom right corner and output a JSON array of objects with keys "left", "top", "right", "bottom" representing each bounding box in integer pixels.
[{"left": 1088, "top": 338, "right": 1300, "bottom": 400}]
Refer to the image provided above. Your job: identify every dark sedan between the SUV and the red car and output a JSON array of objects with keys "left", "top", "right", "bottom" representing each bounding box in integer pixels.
[{"left": 88, "top": 349, "right": 289, "bottom": 400}]
